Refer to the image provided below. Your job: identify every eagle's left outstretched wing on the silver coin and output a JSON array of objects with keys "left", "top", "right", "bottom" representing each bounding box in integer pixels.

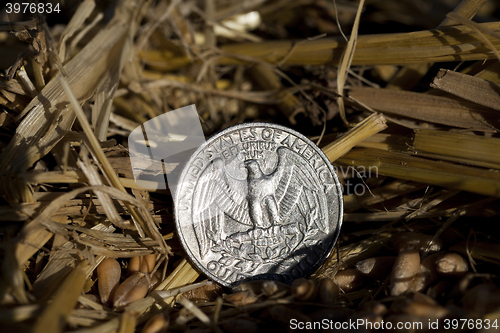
[{"left": 192, "top": 158, "right": 252, "bottom": 259}]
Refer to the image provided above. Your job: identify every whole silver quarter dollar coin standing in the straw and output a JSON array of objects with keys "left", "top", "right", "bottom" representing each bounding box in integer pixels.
[{"left": 175, "top": 123, "right": 342, "bottom": 286}]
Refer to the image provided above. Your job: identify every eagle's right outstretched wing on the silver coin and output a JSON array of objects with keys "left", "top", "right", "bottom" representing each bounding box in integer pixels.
[{"left": 273, "top": 147, "right": 328, "bottom": 232}]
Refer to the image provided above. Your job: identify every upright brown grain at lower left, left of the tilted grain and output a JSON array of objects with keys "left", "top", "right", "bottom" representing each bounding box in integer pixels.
[{"left": 97, "top": 258, "right": 122, "bottom": 305}]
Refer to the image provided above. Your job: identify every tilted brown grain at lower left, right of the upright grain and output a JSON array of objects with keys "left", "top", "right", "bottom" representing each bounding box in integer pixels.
[{"left": 113, "top": 272, "right": 151, "bottom": 310}]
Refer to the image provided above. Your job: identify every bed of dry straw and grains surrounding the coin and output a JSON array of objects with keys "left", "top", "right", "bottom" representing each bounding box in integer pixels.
[{"left": 0, "top": 0, "right": 500, "bottom": 333}]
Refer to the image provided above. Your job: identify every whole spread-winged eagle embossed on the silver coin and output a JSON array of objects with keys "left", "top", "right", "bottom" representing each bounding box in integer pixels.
[{"left": 192, "top": 147, "right": 329, "bottom": 260}]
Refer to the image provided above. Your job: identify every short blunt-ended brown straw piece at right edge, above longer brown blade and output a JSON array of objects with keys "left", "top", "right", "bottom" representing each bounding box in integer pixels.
[{"left": 431, "top": 69, "right": 500, "bottom": 110}]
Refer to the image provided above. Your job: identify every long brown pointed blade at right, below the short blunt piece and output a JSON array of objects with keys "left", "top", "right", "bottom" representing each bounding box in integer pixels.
[{"left": 349, "top": 87, "right": 500, "bottom": 132}]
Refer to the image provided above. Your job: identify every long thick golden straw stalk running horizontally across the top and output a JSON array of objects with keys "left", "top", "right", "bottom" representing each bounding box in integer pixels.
[{"left": 141, "top": 22, "right": 500, "bottom": 70}]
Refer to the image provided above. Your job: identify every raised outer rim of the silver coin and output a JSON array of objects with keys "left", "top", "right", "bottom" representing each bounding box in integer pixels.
[{"left": 174, "top": 122, "right": 344, "bottom": 287}]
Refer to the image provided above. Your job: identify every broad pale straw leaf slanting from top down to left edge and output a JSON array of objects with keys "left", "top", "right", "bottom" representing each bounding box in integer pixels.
[{"left": 0, "top": 1, "right": 145, "bottom": 202}]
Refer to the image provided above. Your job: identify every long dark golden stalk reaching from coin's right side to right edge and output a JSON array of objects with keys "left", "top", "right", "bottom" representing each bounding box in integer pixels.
[{"left": 338, "top": 149, "right": 500, "bottom": 197}]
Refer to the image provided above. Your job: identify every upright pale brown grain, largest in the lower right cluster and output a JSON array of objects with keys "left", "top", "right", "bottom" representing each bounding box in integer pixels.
[{"left": 390, "top": 248, "right": 420, "bottom": 296}]
